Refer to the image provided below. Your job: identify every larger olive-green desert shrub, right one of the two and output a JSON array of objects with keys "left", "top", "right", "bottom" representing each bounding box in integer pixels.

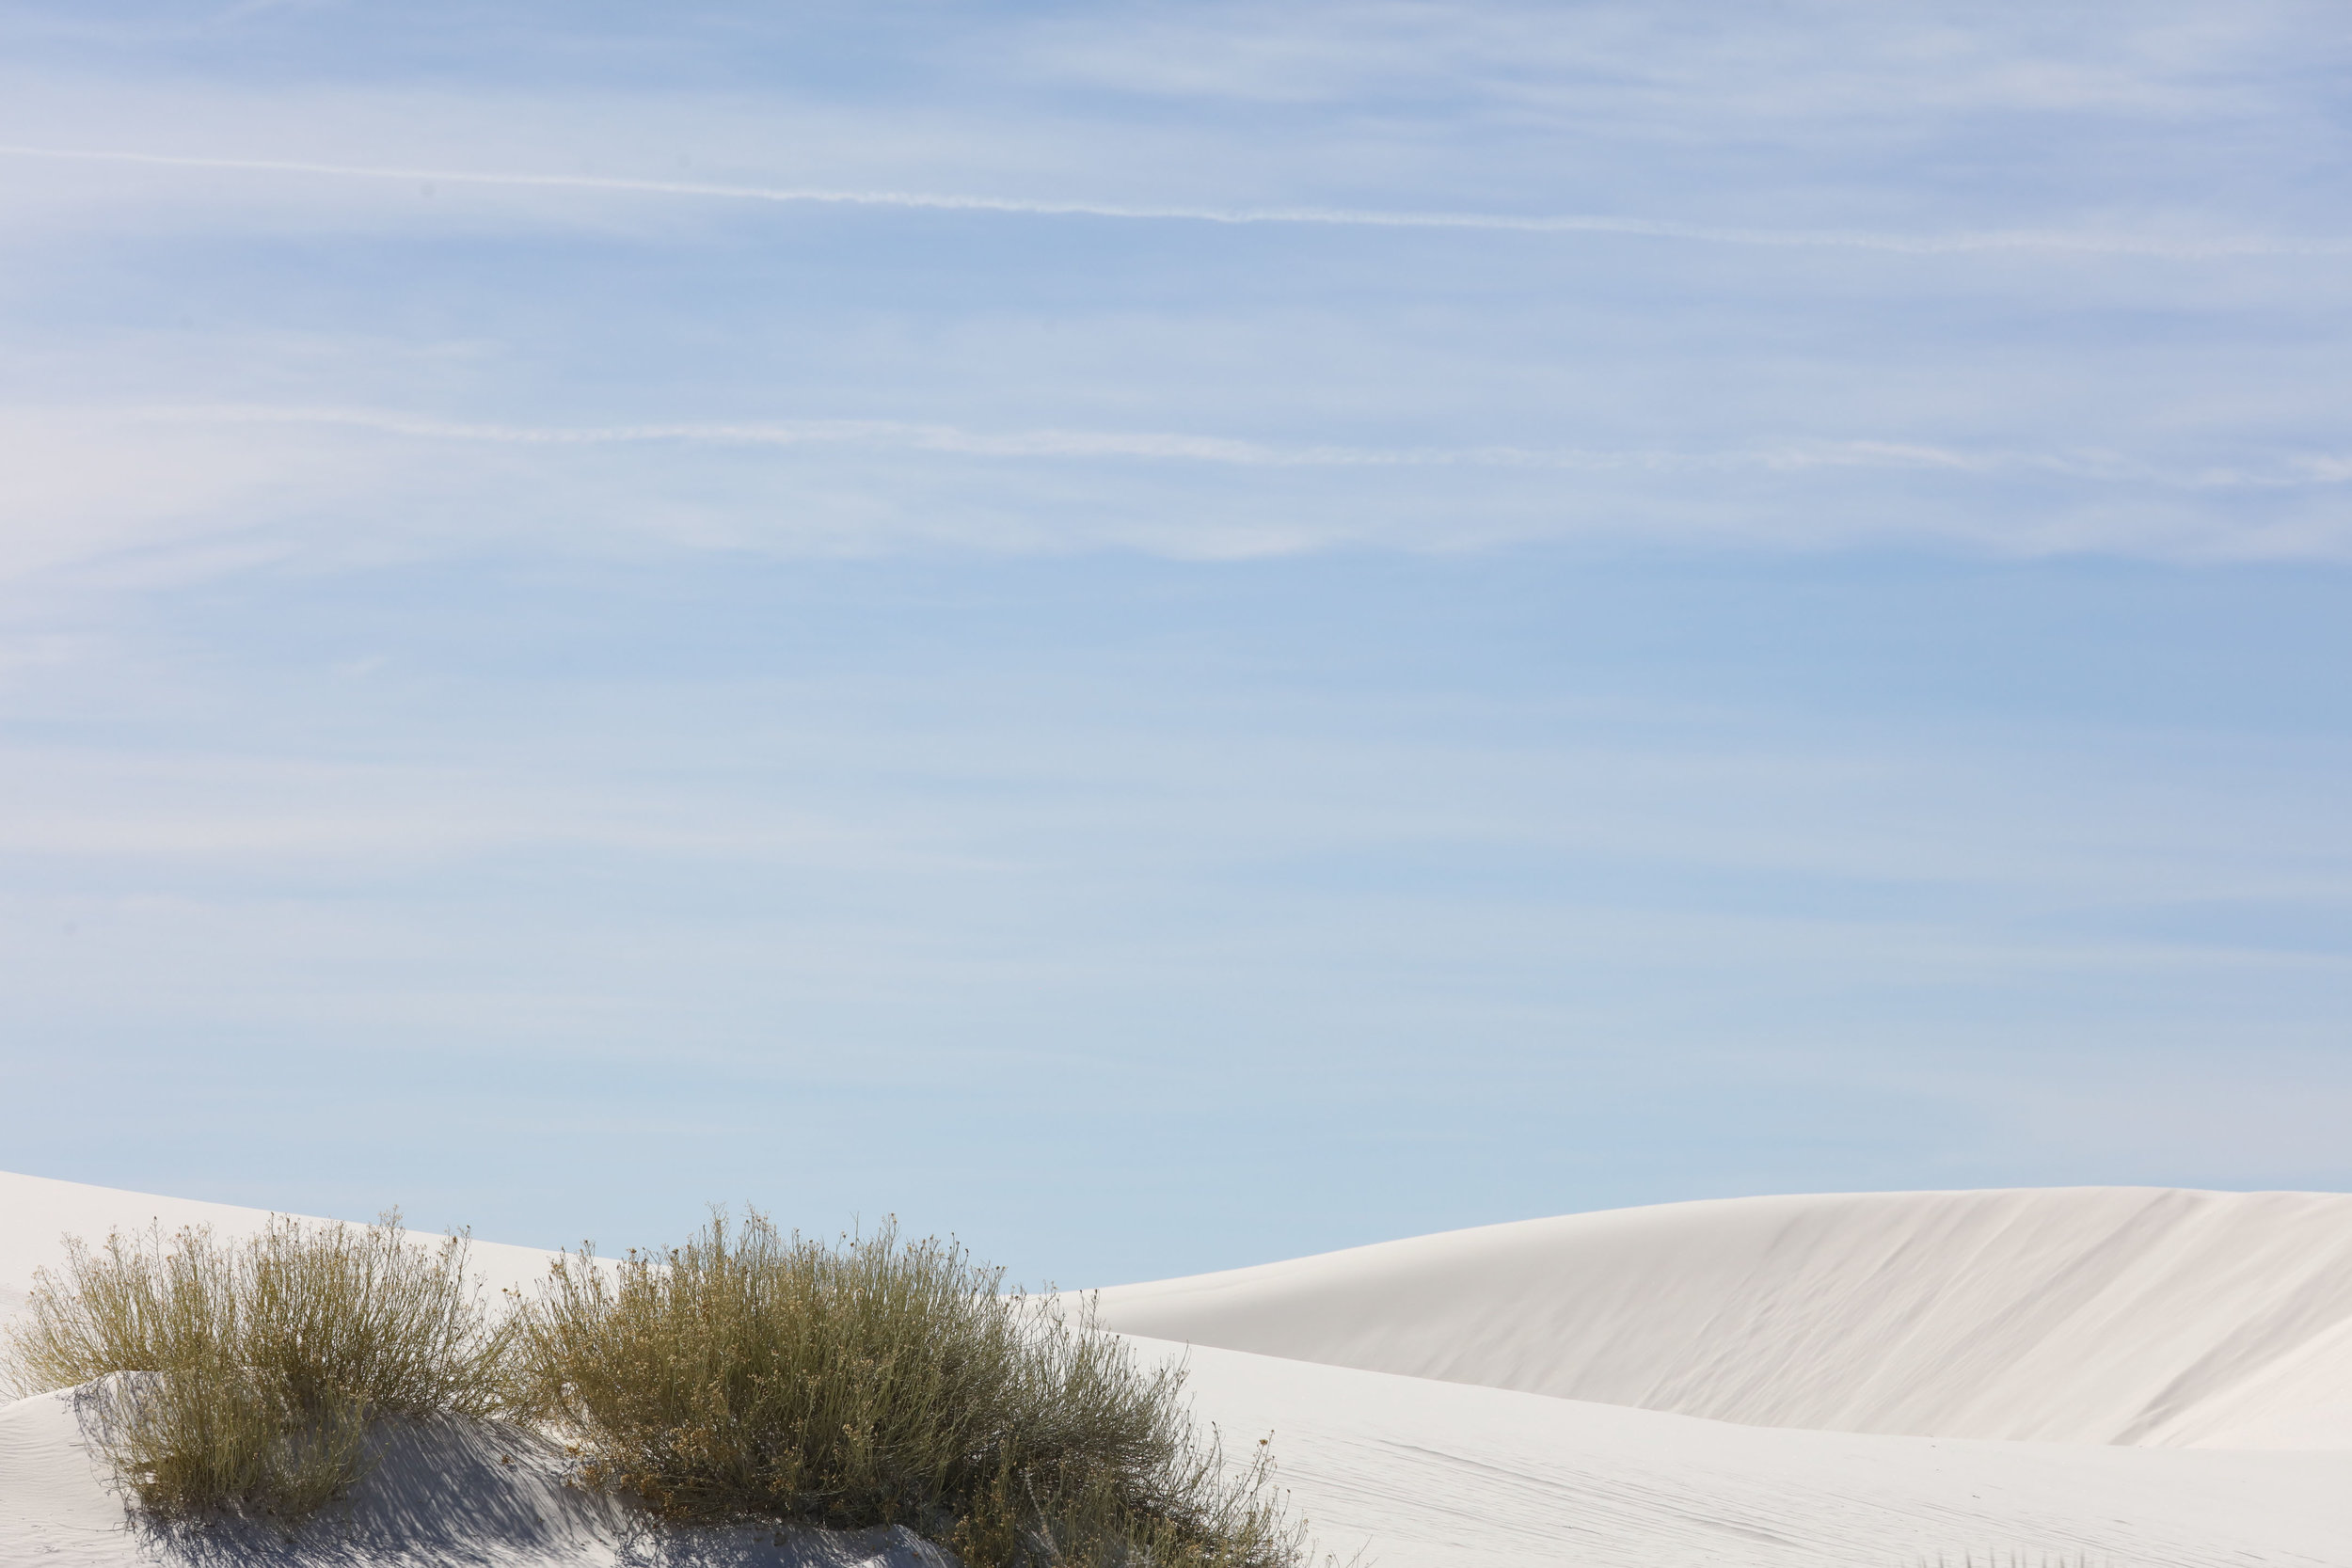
[{"left": 516, "top": 1213, "right": 1303, "bottom": 1568}]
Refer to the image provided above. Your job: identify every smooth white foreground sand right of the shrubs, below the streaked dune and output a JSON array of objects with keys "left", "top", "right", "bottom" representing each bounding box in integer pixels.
[{"left": 1167, "top": 1340, "right": 2352, "bottom": 1568}]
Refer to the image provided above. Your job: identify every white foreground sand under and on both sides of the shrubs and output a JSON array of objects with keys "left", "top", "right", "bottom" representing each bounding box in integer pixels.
[{"left": 0, "top": 1340, "right": 2352, "bottom": 1568}]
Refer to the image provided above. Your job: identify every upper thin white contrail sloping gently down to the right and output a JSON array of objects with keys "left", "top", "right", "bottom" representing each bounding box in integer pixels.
[{"left": 0, "top": 146, "right": 2352, "bottom": 259}]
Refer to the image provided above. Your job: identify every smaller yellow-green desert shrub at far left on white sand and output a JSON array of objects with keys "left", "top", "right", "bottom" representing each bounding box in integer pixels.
[{"left": 0, "top": 1211, "right": 508, "bottom": 1524}]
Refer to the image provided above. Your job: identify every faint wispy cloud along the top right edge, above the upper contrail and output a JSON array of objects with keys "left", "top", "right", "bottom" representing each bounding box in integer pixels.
[{"left": 1016, "top": 0, "right": 2317, "bottom": 138}]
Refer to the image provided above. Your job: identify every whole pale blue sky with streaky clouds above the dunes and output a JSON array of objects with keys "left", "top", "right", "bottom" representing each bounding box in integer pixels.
[{"left": 0, "top": 0, "right": 2352, "bottom": 1284}]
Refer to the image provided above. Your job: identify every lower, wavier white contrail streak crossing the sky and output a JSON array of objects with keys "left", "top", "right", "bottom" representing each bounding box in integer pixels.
[{"left": 130, "top": 404, "right": 2352, "bottom": 489}]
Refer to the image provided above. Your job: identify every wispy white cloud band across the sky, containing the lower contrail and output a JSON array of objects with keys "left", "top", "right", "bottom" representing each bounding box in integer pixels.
[{"left": 0, "top": 402, "right": 2352, "bottom": 583}]
